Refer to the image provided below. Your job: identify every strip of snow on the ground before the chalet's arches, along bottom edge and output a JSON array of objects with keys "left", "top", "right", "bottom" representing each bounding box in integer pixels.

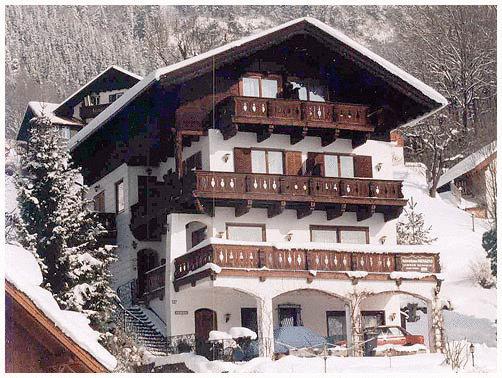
[{"left": 155, "top": 344, "right": 497, "bottom": 376}]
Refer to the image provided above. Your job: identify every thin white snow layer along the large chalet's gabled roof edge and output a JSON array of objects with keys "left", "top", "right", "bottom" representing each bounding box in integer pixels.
[{"left": 69, "top": 17, "right": 448, "bottom": 149}]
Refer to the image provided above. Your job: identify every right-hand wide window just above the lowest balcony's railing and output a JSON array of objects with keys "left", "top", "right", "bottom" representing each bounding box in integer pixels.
[{"left": 310, "top": 226, "right": 369, "bottom": 244}]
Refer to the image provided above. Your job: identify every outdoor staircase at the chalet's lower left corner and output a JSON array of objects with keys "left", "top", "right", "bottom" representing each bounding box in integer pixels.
[{"left": 121, "top": 306, "right": 168, "bottom": 356}]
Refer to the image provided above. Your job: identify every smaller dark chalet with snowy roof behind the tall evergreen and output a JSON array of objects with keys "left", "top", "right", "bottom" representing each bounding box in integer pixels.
[{"left": 17, "top": 66, "right": 142, "bottom": 142}]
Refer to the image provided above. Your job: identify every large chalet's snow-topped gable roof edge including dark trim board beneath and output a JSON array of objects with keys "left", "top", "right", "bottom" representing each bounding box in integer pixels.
[{"left": 69, "top": 17, "right": 448, "bottom": 149}]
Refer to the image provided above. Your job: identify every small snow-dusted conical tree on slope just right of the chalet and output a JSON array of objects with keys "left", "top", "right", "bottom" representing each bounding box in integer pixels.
[{"left": 397, "top": 197, "right": 437, "bottom": 244}]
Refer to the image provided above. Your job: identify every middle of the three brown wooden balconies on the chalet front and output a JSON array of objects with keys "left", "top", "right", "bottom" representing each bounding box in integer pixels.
[{"left": 183, "top": 171, "right": 406, "bottom": 221}]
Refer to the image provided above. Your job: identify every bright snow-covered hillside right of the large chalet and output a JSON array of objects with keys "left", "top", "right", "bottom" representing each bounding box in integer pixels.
[{"left": 395, "top": 164, "right": 497, "bottom": 321}]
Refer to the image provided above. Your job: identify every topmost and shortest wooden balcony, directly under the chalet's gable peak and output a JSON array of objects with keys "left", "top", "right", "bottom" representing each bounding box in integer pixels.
[{"left": 217, "top": 96, "right": 374, "bottom": 145}]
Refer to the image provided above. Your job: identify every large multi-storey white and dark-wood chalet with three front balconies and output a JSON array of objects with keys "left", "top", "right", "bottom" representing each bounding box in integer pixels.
[{"left": 69, "top": 18, "right": 447, "bottom": 356}]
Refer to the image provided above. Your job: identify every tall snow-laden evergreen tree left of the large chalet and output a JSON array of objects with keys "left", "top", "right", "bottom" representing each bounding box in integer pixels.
[{"left": 17, "top": 117, "right": 116, "bottom": 332}]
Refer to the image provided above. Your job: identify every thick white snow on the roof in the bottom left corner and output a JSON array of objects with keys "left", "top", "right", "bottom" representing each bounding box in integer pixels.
[{"left": 4, "top": 244, "right": 117, "bottom": 370}]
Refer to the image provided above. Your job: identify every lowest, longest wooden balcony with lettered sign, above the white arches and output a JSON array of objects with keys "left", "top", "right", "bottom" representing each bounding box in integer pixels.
[{"left": 174, "top": 241, "right": 441, "bottom": 290}]
